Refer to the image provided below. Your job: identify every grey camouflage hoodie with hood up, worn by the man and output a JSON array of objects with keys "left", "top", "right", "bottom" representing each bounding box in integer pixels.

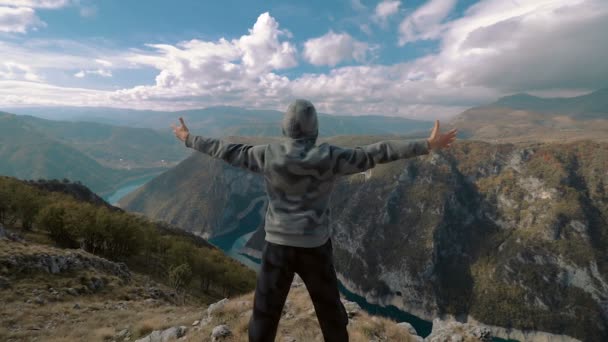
[{"left": 185, "top": 100, "right": 429, "bottom": 247}]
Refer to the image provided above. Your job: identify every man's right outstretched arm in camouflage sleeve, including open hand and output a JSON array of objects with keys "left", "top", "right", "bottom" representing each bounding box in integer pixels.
[{"left": 330, "top": 120, "right": 457, "bottom": 175}]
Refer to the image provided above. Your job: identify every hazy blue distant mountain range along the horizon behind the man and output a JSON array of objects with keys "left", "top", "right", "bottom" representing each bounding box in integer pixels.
[{"left": 5, "top": 106, "right": 429, "bottom": 137}]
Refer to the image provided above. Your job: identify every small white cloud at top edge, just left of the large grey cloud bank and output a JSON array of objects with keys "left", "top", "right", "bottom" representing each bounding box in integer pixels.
[{"left": 399, "top": 0, "right": 456, "bottom": 45}]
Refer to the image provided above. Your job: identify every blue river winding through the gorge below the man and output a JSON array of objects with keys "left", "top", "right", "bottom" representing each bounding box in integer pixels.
[{"left": 104, "top": 180, "right": 517, "bottom": 342}]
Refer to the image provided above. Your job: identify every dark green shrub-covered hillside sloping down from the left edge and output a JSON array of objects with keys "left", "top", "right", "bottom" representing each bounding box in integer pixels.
[{"left": 0, "top": 176, "right": 255, "bottom": 298}]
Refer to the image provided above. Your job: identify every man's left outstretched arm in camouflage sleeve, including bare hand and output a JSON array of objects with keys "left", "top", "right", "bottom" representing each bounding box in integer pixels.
[{"left": 171, "top": 117, "right": 266, "bottom": 172}]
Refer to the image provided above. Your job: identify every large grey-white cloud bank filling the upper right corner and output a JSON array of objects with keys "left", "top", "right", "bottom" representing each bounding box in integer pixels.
[{"left": 434, "top": 0, "right": 608, "bottom": 92}]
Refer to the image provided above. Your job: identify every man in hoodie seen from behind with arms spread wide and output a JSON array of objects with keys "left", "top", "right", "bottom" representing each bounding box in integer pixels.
[{"left": 171, "top": 100, "right": 456, "bottom": 342}]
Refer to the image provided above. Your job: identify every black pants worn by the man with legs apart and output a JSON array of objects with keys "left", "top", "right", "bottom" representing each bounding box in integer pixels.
[{"left": 249, "top": 239, "right": 348, "bottom": 342}]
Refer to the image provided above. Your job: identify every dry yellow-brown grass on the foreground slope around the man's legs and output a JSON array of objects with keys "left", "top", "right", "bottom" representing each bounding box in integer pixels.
[{"left": 0, "top": 232, "right": 414, "bottom": 342}]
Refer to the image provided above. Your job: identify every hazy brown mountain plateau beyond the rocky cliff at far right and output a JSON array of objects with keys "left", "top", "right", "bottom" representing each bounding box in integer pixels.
[{"left": 448, "top": 89, "right": 608, "bottom": 142}]
